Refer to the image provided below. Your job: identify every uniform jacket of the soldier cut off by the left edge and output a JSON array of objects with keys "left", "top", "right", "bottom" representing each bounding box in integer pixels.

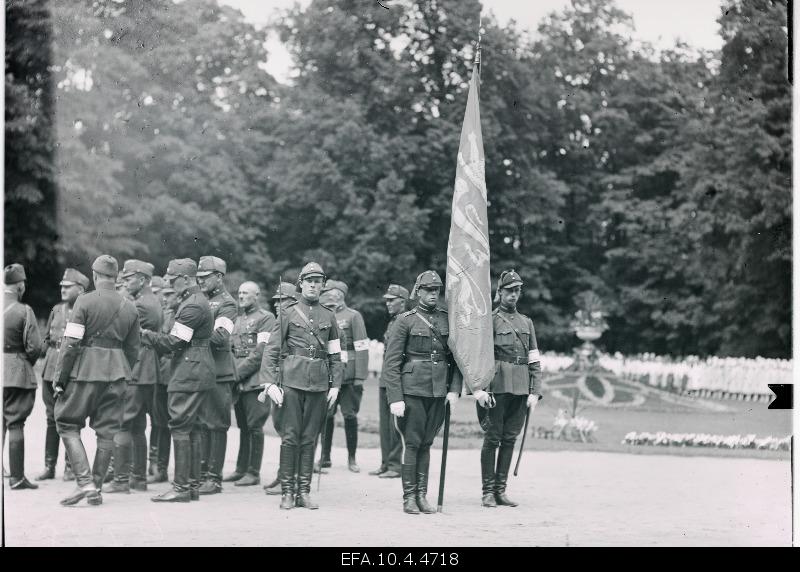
[{"left": 3, "top": 293, "right": 42, "bottom": 389}]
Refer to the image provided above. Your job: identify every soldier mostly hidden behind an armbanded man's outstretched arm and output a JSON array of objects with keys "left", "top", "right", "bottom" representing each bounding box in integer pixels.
[{"left": 147, "top": 276, "right": 178, "bottom": 483}]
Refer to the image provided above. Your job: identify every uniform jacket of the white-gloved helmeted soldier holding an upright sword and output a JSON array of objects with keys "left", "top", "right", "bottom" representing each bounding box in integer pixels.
[{"left": 259, "top": 297, "right": 343, "bottom": 391}]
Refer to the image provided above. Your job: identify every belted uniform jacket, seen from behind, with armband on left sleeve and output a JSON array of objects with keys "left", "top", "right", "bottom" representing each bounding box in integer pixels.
[{"left": 53, "top": 284, "right": 140, "bottom": 384}]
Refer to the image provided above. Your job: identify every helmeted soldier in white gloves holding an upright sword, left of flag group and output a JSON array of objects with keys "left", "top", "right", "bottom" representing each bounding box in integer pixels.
[{"left": 259, "top": 262, "right": 342, "bottom": 510}]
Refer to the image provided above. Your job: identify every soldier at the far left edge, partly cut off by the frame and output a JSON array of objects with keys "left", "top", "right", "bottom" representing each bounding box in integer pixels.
[{"left": 3, "top": 263, "right": 43, "bottom": 491}]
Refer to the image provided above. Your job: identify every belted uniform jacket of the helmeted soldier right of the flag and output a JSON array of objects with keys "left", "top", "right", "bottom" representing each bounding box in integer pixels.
[{"left": 488, "top": 308, "right": 542, "bottom": 396}]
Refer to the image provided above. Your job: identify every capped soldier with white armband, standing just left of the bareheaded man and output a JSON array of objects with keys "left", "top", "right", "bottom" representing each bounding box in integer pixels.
[{"left": 197, "top": 256, "right": 239, "bottom": 495}]
